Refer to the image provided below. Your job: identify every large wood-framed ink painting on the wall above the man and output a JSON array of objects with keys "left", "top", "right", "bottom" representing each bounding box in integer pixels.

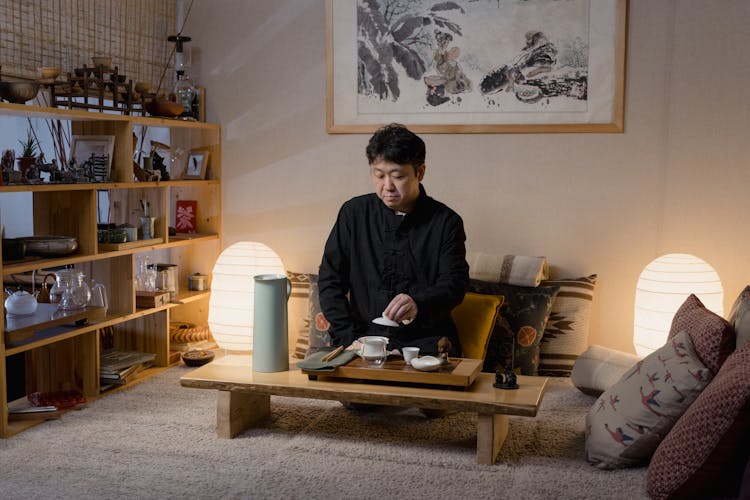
[{"left": 326, "top": 0, "right": 627, "bottom": 133}]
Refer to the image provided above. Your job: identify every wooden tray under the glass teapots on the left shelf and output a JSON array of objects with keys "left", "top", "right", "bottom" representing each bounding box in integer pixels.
[{"left": 5, "top": 303, "right": 105, "bottom": 345}]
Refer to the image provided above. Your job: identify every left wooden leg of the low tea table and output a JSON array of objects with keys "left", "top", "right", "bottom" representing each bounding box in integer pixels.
[{"left": 216, "top": 391, "right": 271, "bottom": 439}]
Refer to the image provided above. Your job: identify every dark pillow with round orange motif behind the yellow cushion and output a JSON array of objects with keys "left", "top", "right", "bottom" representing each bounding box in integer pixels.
[{"left": 469, "top": 279, "right": 558, "bottom": 375}]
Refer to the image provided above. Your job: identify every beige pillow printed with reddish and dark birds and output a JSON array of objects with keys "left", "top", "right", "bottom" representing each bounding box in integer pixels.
[{"left": 586, "top": 331, "right": 713, "bottom": 469}]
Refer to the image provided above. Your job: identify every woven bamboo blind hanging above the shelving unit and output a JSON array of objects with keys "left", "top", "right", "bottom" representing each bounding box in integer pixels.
[{"left": 0, "top": 0, "right": 177, "bottom": 89}]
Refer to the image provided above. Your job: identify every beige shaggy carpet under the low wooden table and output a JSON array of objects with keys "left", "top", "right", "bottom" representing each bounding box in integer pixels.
[{"left": 0, "top": 366, "right": 646, "bottom": 500}]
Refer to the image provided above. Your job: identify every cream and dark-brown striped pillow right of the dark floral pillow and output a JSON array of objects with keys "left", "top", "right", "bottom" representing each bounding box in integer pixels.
[{"left": 539, "top": 274, "right": 597, "bottom": 377}]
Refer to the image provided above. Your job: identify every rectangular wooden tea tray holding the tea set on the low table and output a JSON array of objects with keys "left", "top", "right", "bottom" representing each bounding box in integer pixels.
[{"left": 302, "top": 357, "right": 483, "bottom": 389}]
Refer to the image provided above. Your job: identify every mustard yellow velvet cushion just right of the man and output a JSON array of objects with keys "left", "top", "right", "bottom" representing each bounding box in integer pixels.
[{"left": 451, "top": 292, "right": 504, "bottom": 359}]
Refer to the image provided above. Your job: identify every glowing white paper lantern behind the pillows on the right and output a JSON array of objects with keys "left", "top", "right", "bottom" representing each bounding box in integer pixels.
[{"left": 633, "top": 253, "right": 724, "bottom": 357}]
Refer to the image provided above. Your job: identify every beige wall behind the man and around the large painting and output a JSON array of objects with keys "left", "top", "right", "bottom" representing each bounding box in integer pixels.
[{"left": 186, "top": 0, "right": 750, "bottom": 351}]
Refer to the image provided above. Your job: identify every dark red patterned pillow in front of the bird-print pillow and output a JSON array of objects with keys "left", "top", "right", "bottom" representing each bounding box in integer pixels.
[{"left": 646, "top": 344, "right": 750, "bottom": 499}]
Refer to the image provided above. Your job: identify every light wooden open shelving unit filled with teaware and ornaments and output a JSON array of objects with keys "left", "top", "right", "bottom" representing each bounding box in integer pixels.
[{"left": 0, "top": 103, "right": 221, "bottom": 438}]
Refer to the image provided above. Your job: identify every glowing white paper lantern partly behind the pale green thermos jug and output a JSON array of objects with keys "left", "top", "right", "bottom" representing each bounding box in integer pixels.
[{"left": 208, "top": 241, "right": 285, "bottom": 351}]
